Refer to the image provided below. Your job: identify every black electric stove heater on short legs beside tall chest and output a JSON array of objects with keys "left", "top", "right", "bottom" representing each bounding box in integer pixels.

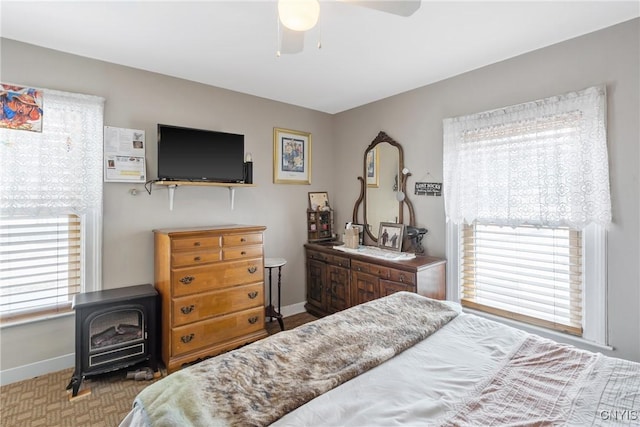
[{"left": 67, "top": 284, "right": 158, "bottom": 397}]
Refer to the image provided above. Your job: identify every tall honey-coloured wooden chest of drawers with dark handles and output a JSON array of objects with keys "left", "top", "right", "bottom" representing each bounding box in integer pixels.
[{"left": 154, "top": 225, "right": 267, "bottom": 373}]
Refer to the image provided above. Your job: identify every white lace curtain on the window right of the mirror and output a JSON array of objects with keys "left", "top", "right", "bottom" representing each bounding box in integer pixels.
[{"left": 443, "top": 87, "right": 611, "bottom": 229}]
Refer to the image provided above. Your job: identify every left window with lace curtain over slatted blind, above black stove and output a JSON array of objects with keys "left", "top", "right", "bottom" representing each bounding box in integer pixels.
[{"left": 0, "top": 90, "right": 104, "bottom": 324}]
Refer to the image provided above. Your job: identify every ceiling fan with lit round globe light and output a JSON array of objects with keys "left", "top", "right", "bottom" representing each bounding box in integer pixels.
[{"left": 277, "top": 0, "right": 421, "bottom": 56}]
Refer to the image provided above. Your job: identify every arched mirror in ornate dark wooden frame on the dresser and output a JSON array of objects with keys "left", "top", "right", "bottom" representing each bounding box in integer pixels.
[{"left": 353, "top": 132, "right": 415, "bottom": 242}]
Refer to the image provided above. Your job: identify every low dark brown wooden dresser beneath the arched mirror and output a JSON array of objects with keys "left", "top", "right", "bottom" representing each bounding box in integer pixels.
[{"left": 304, "top": 243, "right": 446, "bottom": 316}]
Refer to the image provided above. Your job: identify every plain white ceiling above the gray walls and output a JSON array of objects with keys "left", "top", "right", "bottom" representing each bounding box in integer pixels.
[{"left": 0, "top": 0, "right": 640, "bottom": 113}]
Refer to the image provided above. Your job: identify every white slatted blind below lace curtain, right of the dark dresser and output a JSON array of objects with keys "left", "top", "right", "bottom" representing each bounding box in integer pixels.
[{"left": 460, "top": 224, "right": 582, "bottom": 336}]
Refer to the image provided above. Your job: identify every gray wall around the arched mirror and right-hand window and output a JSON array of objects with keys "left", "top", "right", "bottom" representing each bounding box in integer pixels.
[{"left": 334, "top": 19, "right": 640, "bottom": 361}]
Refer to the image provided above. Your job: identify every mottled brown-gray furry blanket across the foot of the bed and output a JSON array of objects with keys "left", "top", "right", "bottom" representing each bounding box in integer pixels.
[{"left": 134, "top": 292, "right": 457, "bottom": 427}]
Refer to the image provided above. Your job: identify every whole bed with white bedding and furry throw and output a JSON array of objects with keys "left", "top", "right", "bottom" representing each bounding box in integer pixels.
[{"left": 121, "top": 292, "right": 640, "bottom": 427}]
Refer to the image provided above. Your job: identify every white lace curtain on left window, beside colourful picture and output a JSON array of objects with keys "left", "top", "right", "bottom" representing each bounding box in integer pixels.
[{"left": 0, "top": 89, "right": 104, "bottom": 216}]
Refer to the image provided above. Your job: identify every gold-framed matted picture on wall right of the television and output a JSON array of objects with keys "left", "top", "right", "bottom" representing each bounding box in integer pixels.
[{"left": 273, "top": 128, "right": 311, "bottom": 184}]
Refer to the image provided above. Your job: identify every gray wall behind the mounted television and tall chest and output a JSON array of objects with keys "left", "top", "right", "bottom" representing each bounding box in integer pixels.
[{"left": 0, "top": 39, "right": 333, "bottom": 372}]
